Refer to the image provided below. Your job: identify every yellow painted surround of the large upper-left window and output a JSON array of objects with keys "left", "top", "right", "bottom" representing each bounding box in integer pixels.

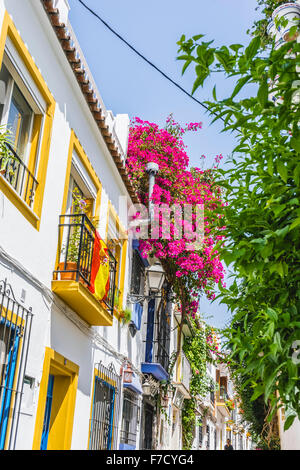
[{"left": 0, "top": 11, "right": 55, "bottom": 230}]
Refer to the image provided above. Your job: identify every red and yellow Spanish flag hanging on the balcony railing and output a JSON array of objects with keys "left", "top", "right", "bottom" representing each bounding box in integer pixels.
[{"left": 89, "top": 231, "right": 109, "bottom": 300}]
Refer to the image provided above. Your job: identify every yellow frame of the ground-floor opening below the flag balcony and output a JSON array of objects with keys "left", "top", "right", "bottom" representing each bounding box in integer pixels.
[{"left": 32, "top": 347, "right": 79, "bottom": 450}]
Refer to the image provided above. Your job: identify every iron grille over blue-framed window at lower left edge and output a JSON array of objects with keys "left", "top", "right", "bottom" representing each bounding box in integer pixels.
[{"left": 0, "top": 281, "right": 32, "bottom": 450}]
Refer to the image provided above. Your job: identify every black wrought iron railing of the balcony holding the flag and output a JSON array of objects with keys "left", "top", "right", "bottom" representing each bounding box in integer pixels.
[{"left": 54, "top": 214, "right": 117, "bottom": 315}]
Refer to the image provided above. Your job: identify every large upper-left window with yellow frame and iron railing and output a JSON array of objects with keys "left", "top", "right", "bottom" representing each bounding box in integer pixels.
[{"left": 0, "top": 12, "right": 55, "bottom": 229}]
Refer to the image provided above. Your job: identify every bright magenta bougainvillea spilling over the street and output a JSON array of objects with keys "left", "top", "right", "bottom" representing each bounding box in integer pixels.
[{"left": 126, "top": 115, "right": 224, "bottom": 324}]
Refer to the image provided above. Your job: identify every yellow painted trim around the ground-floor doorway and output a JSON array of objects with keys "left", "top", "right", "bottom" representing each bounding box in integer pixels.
[{"left": 32, "top": 348, "right": 79, "bottom": 450}]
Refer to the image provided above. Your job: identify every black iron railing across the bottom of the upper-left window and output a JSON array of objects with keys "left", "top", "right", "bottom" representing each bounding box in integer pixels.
[{"left": 0, "top": 143, "right": 38, "bottom": 207}]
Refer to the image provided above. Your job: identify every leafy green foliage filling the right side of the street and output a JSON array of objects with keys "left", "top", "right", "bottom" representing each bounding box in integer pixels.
[{"left": 178, "top": 10, "right": 300, "bottom": 434}]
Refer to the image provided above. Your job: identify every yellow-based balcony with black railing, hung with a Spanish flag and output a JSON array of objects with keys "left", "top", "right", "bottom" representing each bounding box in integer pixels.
[{"left": 52, "top": 214, "right": 116, "bottom": 326}]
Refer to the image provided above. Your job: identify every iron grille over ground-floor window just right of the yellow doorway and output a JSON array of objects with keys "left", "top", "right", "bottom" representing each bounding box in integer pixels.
[{"left": 89, "top": 363, "right": 121, "bottom": 450}]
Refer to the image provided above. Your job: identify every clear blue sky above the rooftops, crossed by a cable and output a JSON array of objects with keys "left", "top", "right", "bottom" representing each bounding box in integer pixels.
[{"left": 69, "top": 0, "right": 258, "bottom": 327}]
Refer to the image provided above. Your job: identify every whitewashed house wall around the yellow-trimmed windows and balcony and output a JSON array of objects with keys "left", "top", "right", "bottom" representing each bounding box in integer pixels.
[{"left": 0, "top": 0, "right": 142, "bottom": 449}]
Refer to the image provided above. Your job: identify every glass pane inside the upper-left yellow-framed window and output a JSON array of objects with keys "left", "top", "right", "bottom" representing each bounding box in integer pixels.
[{"left": 7, "top": 84, "right": 33, "bottom": 160}]
